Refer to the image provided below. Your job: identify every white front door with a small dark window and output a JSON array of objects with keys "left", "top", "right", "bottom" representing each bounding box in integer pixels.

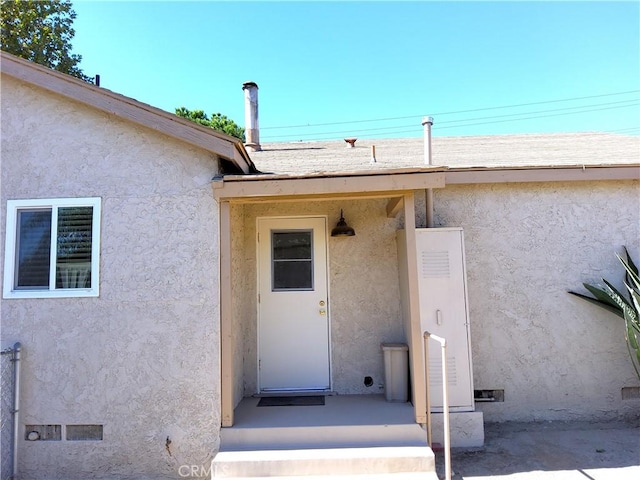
[{"left": 257, "top": 217, "right": 330, "bottom": 392}]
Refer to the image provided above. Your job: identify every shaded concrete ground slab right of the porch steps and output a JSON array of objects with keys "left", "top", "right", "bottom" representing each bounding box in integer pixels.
[{"left": 435, "top": 419, "right": 640, "bottom": 480}]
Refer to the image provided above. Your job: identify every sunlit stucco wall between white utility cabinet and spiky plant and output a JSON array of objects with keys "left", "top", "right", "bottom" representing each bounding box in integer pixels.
[{"left": 418, "top": 181, "right": 640, "bottom": 421}]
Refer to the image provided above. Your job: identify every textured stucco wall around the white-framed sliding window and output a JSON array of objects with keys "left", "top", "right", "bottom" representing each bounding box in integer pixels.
[{"left": 0, "top": 77, "right": 220, "bottom": 479}]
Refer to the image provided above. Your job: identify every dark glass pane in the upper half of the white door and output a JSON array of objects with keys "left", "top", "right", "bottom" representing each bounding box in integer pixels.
[{"left": 271, "top": 230, "right": 313, "bottom": 291}]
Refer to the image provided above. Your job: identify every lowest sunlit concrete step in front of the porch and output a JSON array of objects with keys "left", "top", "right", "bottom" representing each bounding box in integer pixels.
[{"left": 212, "top": 446, "right": 437, "bottom": 480}]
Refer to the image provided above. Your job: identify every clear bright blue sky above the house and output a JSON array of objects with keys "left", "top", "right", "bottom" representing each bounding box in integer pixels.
[{"left": 73, "top": 0, "right": 640, "bottom": 143}]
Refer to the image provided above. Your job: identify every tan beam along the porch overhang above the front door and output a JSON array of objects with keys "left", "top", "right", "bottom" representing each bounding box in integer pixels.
[{"left": 213, "top": 169, "right": 445, "bottom": 201}]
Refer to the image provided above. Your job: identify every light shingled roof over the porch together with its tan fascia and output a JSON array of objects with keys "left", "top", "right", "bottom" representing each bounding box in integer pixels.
[{"left": 214, "top": 133, "right": 640, "bottom": 201}]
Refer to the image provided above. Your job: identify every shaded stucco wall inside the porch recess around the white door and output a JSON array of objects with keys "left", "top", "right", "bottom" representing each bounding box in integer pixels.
[{"left": 235, "top": 200, "right": 404, "bottom": 395}]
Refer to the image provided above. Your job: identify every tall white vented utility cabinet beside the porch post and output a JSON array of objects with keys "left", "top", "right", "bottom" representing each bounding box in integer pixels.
[{"left": 398, "top": 227, "right": 474, "bottom": 412}]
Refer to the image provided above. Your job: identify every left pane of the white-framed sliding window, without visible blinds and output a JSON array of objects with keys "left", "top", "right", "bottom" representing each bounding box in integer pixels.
[{"left": 15, "top": 209, "right": 51, "bottom": 289}]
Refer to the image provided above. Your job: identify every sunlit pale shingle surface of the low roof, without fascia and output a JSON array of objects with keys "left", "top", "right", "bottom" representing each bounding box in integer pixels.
[{"left": 251, "top": 133, "right": 640, "bottom": 176}]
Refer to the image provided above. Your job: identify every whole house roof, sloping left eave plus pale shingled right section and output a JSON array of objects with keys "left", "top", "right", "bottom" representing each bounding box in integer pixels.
[{"left": 0, "top": 52, "right": 640, "bottom": 183}]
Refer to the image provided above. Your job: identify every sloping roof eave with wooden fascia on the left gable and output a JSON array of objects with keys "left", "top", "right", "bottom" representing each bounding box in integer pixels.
[{"left": 0, "top": 52, "right": 257, "bottom": 173}]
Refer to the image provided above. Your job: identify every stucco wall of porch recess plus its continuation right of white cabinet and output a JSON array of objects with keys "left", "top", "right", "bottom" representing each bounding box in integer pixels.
[{"left": 231, "top": 181, "right": 640, "bottom": 421}]
